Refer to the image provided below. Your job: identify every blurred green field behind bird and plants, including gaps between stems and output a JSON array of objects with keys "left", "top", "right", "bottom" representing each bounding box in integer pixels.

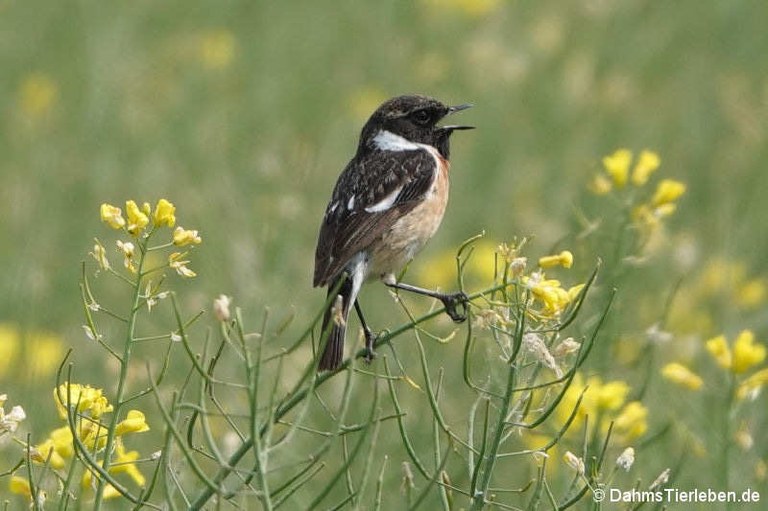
[{"left": 0, "top": 0, "right": 768, "bottom": 509}]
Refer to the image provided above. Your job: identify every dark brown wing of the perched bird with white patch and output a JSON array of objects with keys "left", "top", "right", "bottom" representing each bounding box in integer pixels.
[{"left": 314, "top": 149, "right": 437, "bottom": 287}]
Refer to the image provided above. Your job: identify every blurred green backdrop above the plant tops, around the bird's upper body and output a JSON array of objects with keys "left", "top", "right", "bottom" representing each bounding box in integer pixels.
[{"left": 0, "top": 0, "right": 768, "bottom": 508}]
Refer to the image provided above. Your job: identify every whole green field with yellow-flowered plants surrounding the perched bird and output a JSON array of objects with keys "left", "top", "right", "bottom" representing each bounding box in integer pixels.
[{"left": 0, "top": 0, "right": 768, "bottom": 509}]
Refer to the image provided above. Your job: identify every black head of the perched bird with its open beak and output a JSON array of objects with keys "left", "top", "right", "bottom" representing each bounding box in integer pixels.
[{"left": 360, "top": 95, "right": 473, "bottom": 158}]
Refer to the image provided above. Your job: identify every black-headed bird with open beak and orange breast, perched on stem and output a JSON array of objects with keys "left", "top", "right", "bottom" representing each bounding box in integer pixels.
[{"left": 313, "top": 94, "right": 474, "bottom": 371}]
